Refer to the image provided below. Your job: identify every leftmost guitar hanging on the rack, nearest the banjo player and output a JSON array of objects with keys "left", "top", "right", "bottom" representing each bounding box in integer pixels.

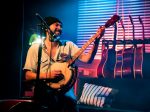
[{"left": 103, "top": 23, "right": 117, "bottom": 78}]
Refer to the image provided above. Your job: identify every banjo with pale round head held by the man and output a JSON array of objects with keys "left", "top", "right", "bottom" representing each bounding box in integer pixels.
[{"left": 40, "top": 15, "right": 119, "bottom": 92}]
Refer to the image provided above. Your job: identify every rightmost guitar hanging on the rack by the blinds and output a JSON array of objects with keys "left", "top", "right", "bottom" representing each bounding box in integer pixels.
[{"left": 133, "top": 16, "right": 145, "bottom": 78}]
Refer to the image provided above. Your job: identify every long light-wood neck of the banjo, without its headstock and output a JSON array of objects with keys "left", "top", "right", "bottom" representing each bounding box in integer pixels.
[{"left": 68, "top": 27, "right": 103, "bottom": 65}]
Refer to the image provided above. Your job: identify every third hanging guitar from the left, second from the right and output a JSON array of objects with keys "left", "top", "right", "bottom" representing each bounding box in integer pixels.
[{"left": 122, "top": 15, "right": 134, "bottom": 78}]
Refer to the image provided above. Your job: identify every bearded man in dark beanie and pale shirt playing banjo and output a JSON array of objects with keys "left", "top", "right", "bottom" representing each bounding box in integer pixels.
[{"left": 24, "top": 17, "right": 104, "bottom": 112}]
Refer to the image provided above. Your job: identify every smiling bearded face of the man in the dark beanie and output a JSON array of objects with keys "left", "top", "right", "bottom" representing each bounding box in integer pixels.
[{"left": 50, "top": 22, "right": 62, "bottom": 36}]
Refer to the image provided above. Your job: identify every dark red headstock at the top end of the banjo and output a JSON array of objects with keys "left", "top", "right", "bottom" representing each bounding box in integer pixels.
[{"left": 105, "top": 15, "right": 120, "bottom": 28}]
